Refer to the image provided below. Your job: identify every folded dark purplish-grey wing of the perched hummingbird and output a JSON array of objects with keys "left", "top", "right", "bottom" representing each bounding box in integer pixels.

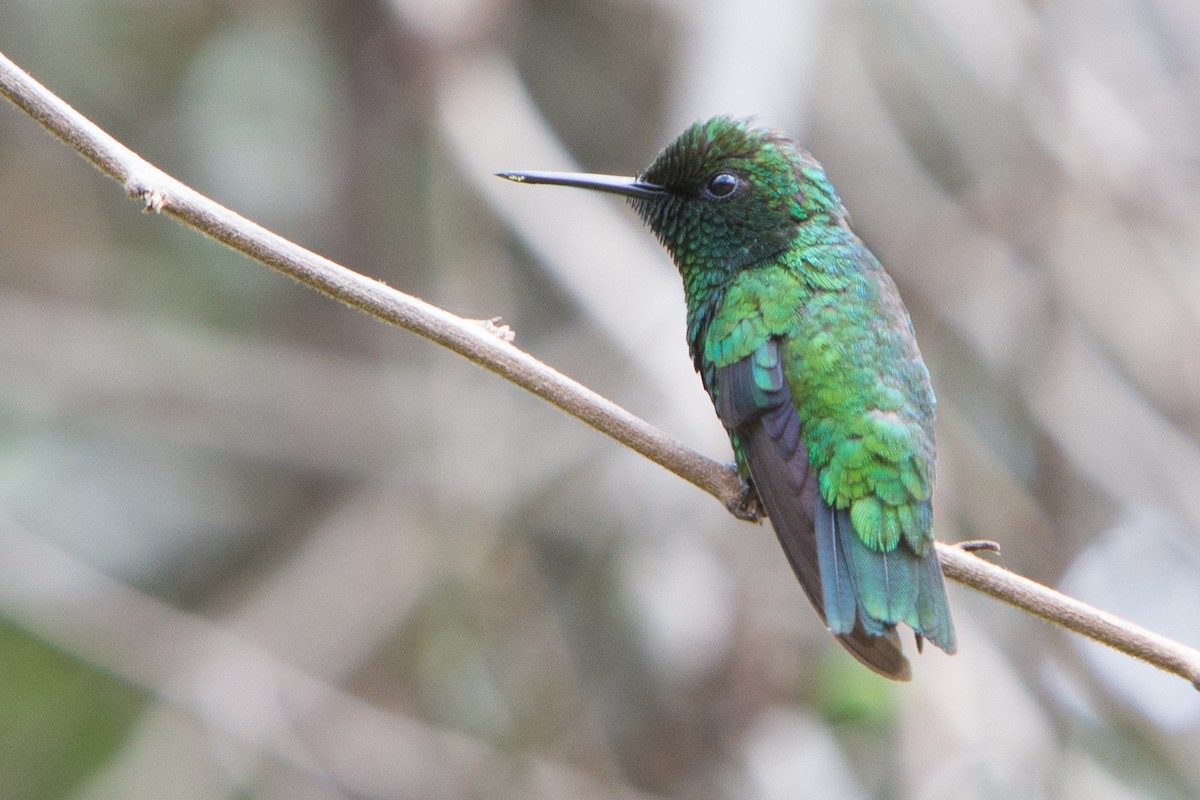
[{"left": 712, "top": 339, "right": 907, "bottom": 680}]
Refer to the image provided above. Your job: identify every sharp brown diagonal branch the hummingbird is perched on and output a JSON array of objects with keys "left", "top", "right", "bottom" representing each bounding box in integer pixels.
[{"left": 0, "top": 48, "right": 1200, "bottom": 688}]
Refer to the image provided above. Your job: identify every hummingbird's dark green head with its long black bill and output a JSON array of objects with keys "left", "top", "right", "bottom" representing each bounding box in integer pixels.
[{"left": 500, "top": 116, "right": 845, "bottom": 283}]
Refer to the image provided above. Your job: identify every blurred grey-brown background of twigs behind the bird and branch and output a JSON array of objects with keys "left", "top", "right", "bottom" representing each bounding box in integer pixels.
[{"left": 0, "top": 0, "right": 1200, "bottom": 800}]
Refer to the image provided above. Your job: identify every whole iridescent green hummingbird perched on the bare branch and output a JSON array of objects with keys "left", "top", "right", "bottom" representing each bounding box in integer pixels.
[{"left": 499, "top": 116, "right": 955, "bottom": 680}]
